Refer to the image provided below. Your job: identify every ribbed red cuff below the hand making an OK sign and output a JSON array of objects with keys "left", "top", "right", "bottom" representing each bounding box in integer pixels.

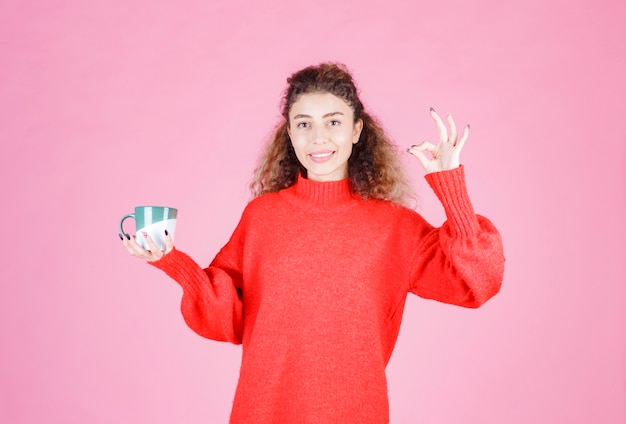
[{"left": 425, "top": 165, "right": 478, "bottom": 236}]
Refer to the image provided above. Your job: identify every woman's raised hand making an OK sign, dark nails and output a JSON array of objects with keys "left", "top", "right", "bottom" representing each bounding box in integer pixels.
[{"left": 407, "top": 108, "right": 469, "bottom": 174}]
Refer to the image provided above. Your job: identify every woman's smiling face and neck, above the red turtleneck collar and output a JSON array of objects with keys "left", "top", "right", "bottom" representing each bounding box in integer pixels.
[{"left": 287, "top": 93, "right": 363, "bottom": 181}]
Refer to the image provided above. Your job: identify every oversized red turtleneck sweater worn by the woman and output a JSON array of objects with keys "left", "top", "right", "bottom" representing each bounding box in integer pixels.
[{"left": 152, "top": 167, "right": 504, "bottom": 424}]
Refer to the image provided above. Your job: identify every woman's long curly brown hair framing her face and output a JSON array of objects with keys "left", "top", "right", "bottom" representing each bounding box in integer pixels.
[{"left": 250, "top": 63, "right": 411, "bottom": 204}]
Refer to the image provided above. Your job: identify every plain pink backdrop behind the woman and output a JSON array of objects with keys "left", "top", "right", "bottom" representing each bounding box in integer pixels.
[{"left": 0, "top": 0, "right": 626, "bottom": 424}]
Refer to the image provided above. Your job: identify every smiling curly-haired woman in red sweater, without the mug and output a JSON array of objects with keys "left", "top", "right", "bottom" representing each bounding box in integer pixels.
[{"left": 120, "top": 64, "right": 504, "bottom": 423}]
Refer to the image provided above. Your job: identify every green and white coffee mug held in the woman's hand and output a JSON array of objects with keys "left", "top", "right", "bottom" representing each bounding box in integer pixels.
[{"left": 120, "top": 206, "right": 178, "bottom": 251}]
